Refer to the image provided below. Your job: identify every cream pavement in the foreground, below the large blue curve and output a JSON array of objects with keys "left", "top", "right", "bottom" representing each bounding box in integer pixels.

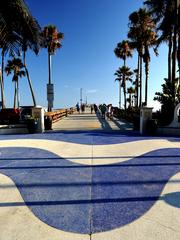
[{"left": 0, "top": 173, "right": 180, "bottom": 240}]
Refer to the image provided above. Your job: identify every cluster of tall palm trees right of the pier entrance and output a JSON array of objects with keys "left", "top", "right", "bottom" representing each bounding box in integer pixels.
[{"left": 114, "top": 0, "right": 180, "bottom": 109}]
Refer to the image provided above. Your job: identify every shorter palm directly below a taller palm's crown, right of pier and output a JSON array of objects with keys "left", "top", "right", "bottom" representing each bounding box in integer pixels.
[{"left": 115, "top": 66, "right": 133, "bottom": 109}]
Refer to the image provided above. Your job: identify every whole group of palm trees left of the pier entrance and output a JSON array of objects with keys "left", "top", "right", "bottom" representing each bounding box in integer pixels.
[{"left": 0, "top": 0, "right": 63, "bottom": 111}]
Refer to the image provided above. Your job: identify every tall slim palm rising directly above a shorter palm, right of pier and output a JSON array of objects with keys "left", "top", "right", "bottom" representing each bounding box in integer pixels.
[{"left": 114, "top": 40, "right": 132, "bottom": 109}]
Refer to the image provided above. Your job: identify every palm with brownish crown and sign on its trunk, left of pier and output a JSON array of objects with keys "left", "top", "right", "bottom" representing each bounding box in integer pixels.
[{"left": 42, "top": 25, "right": 64, "bottom": 111}]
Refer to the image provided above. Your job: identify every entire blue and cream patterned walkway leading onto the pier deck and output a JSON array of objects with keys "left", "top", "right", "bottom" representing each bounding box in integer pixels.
[{"left": 0, "top": 108, "right": 180, "bottom": 240}]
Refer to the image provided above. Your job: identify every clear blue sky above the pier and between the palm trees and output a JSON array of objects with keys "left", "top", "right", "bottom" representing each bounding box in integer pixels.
[{"left": 5, "top": 0, "right": 167, "bottom": 108}]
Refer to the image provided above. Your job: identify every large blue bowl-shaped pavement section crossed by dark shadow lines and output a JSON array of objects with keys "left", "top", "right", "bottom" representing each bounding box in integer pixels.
[{"left": 0, "top": 140, "right": 180, "bottom": 234}]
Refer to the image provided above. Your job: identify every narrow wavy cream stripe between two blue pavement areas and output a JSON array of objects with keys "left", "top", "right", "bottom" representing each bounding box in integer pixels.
[{"left": 0, "top": 139, "right": 180, "bottom": 165}]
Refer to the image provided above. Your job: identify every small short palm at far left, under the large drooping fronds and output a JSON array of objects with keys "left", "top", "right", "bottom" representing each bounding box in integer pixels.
[{"left": 5, "top": 58, "right": 26, "bottom": 109}]
